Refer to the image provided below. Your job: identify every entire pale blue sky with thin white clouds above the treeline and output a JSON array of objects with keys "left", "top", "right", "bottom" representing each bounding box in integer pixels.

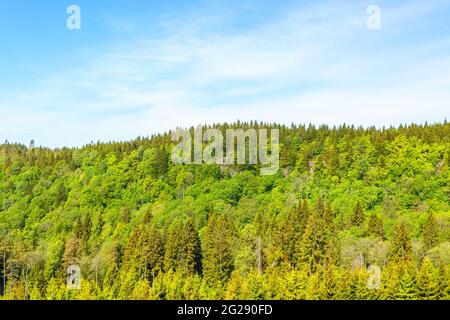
[{"left": 0, "top": 0, "right": 450, "bottom": 147}]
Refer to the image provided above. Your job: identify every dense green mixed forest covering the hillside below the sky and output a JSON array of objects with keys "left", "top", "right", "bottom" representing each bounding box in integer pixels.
[{"left": 0, "top": 121, "right": 450, "bottom": 300}]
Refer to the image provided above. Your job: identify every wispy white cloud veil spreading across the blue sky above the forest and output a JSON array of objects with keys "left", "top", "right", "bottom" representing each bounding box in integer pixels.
[{"left": 0, "top": 1, "right": 450, "bottom": 146}]
